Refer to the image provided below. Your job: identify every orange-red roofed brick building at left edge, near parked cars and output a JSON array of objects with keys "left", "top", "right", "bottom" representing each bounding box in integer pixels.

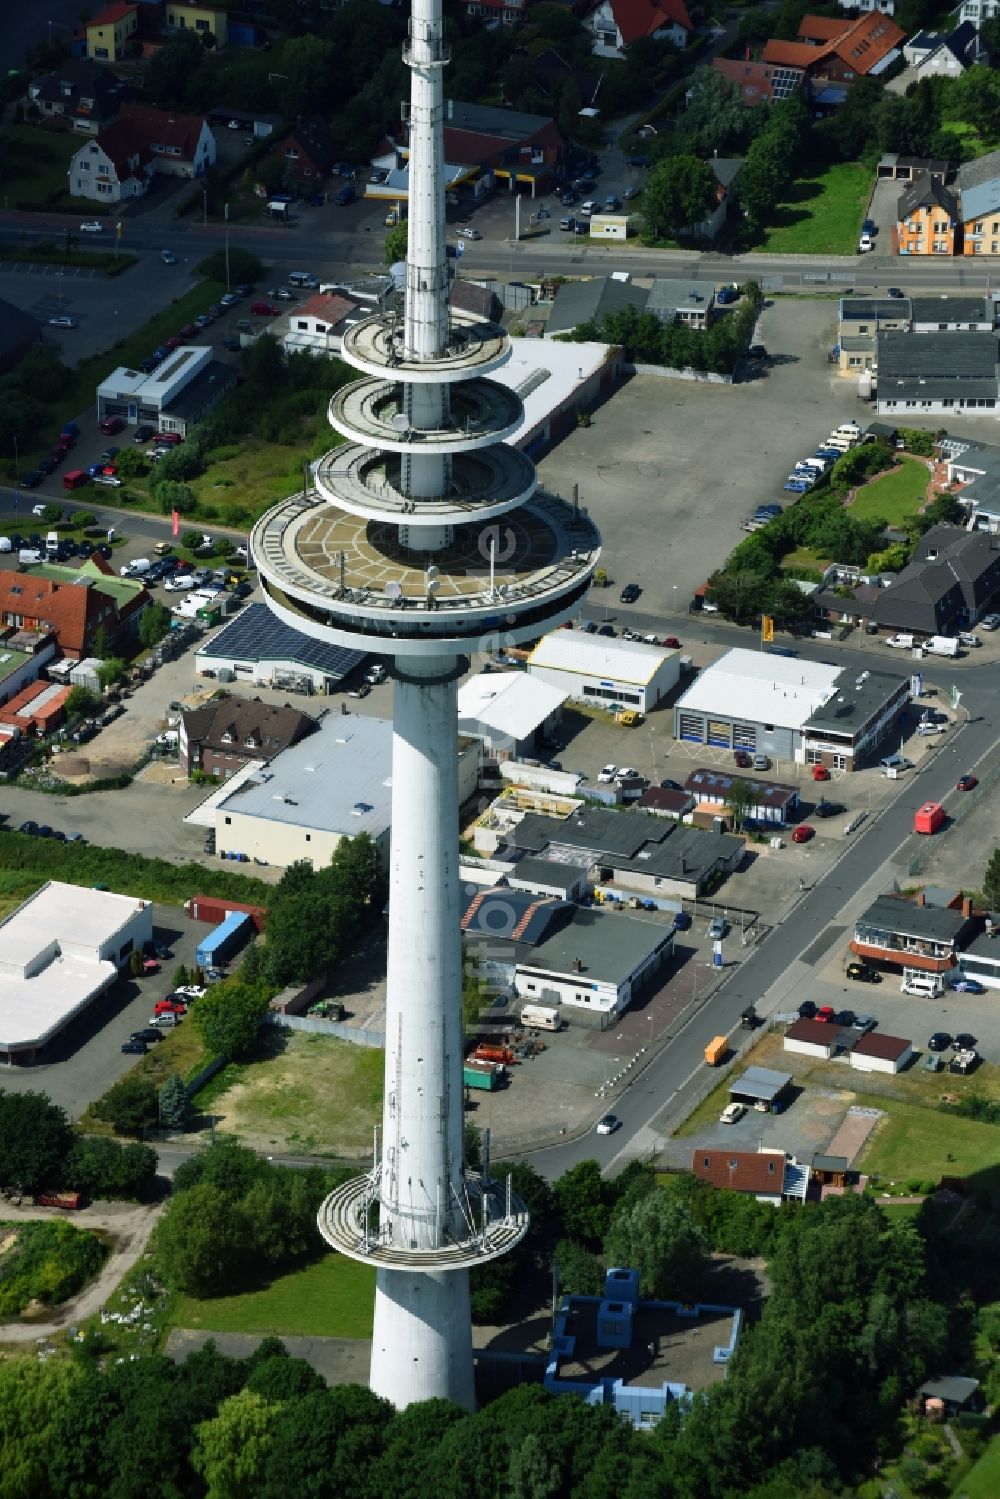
[{"left": 0, "top": 559, "right": 153, "bottom": 661}]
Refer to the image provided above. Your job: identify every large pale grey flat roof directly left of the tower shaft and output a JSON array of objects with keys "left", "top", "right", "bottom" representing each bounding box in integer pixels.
[{"left": 217, "top": 714, "right": 393, "bottom": 838}]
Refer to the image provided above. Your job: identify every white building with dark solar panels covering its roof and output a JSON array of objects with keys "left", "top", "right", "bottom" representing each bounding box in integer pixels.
[{"left": 195, "top": 604, "right": 364, "bottom": 693}]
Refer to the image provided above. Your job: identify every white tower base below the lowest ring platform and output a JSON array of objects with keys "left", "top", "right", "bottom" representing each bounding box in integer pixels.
[{"left": 370, "top": 1270, "right": 475, "bottom": 1411}]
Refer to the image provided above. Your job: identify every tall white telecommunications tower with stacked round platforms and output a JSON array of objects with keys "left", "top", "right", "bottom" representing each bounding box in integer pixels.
[{"left": 252, "top": 0, "right": 600, "bottom": 1409}]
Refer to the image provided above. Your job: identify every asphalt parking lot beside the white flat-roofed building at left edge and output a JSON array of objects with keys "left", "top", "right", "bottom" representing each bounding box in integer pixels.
[{"left": 0, "top": 892, "right": 208, "bottom": 1120}]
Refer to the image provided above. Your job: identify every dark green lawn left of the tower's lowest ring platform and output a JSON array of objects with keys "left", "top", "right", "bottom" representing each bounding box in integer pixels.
[{"left": 171, "top": 1253, "right": 375, "bottom": 1337}]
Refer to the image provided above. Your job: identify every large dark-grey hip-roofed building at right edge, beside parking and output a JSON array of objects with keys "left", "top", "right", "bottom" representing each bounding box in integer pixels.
[{"left": 871, "top": 526, "right": 1000, "bottom": 636}]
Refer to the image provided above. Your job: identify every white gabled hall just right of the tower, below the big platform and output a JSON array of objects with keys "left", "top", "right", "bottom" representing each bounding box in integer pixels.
[{"left": 528, "top": 630, "right": 681, "bottom": 714}]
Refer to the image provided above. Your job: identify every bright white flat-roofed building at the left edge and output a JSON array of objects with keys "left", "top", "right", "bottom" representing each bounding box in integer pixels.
[{"left": 0, "top": 880, "right": 153, "bottom": 1066}]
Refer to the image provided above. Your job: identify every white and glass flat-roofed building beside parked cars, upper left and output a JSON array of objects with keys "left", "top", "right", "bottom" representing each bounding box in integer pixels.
[{"left": 97, "top": 343, "right": 235, "bottom": 438}]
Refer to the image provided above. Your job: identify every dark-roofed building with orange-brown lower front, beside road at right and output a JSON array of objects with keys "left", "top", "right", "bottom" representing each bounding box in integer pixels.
[{"left": 850, "top": 892, "right": 982, "bottom": 973}]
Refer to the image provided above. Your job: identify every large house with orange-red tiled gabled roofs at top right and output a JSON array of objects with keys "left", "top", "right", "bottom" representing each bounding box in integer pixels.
[{"left": 763, "top": 10, "right": 906, "bottom": 109}]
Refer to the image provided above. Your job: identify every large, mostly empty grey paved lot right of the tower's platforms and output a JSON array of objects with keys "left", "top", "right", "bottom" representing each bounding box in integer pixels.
[{"left": 538, "top": 298, "right": 867, "bottom": 612}]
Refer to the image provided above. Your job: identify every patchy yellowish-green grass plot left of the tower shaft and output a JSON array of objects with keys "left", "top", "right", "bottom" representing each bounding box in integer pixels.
[{"left": 209, "top": 1027, "right": 384, "bottom": 1159}]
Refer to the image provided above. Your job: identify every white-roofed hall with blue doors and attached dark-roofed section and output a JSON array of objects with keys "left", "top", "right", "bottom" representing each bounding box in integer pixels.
[{"left": 673, "top": 649, "right": 910, "bottom": 770}]
